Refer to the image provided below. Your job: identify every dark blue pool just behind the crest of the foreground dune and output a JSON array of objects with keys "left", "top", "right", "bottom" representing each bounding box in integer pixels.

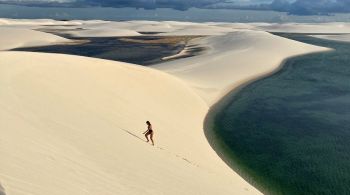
[{"left": 13, "top": 37, "right": 190, "bottom": 65}]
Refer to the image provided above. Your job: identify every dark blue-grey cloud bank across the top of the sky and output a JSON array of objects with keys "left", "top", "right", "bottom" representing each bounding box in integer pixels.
[{"left": 0, "top": 0, "right": 350, "bottom": 16}]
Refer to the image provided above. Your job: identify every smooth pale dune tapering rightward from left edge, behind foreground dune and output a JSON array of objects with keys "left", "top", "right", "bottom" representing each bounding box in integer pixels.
[{"left": 0, "top": 26, "right": 70, "bottom": 51}]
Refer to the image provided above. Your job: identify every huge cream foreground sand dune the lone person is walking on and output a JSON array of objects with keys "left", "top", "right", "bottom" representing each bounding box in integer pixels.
[{"left": 0, "top": 52, "right": 259, "bottom": 195}]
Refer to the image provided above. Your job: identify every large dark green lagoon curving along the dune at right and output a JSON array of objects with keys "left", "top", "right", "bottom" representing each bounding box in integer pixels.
[{"left": 213, "top": 34, "right": 350, "bottom": 195}]
